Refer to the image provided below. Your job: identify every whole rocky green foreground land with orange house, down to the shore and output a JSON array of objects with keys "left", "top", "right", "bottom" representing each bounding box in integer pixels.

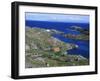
[{"left": 25, "top": 27, "right": 89, "bottom": 68}]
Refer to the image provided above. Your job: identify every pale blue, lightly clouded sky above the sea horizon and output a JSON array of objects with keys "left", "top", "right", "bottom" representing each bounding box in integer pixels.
[{"left": 25, "top": 12, "right": 89, "bottom": 23}]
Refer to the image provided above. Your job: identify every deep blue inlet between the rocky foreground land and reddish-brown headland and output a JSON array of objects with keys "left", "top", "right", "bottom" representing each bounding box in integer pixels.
[{"left": 54, "top": 35, "right": 89, "bottom": 58}]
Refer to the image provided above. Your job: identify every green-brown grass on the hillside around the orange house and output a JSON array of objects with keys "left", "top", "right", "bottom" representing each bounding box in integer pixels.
[{"left": 25, "top": 28, "right": 88, "bottom": 67}]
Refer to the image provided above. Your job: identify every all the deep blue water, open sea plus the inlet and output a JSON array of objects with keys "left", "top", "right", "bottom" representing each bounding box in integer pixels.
[{"left": 25, "top": 20, "right": 89, "bottom": 58}]
